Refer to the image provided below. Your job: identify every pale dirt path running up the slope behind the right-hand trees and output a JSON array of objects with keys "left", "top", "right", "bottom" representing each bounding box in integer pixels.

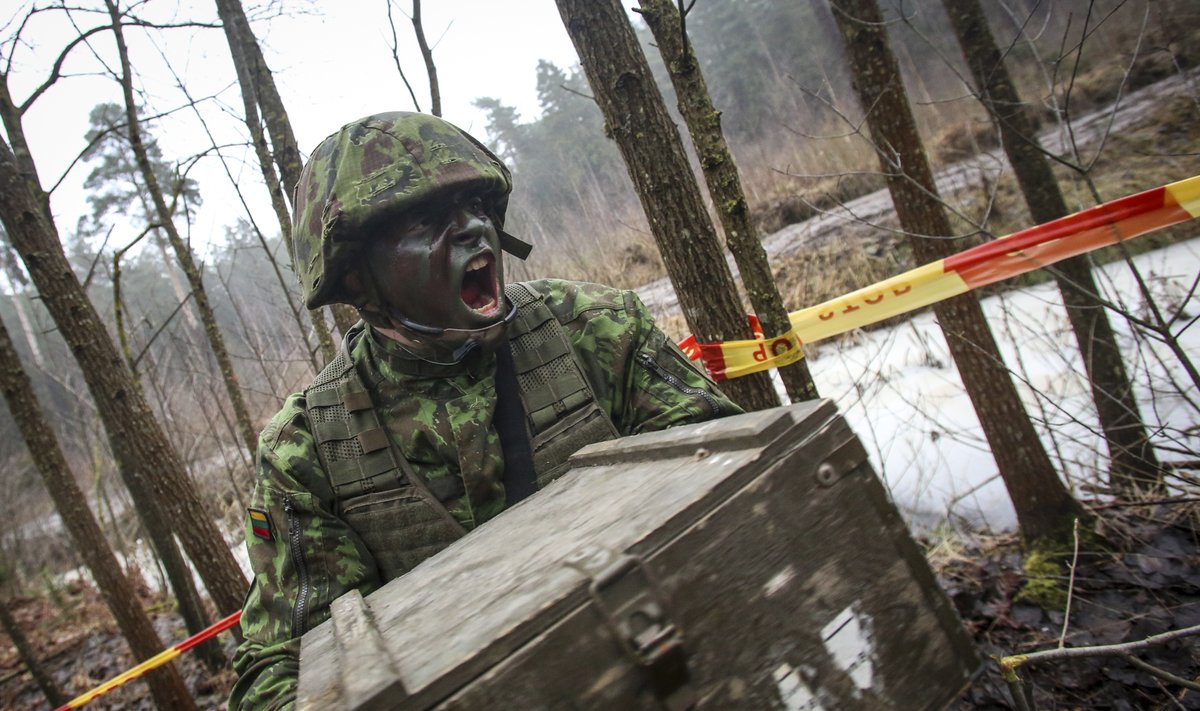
[{"left": 636, "top": 70, "right": 1200, "bottom": 317}]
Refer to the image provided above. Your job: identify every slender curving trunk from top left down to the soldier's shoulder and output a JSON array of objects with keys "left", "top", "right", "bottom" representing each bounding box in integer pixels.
[{"left": 104, "top": 0, "right": 258, "bottom": 458}]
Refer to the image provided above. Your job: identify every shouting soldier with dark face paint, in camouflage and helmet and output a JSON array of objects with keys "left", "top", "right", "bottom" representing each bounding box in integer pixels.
[{"left": 229, "top": 113, "right": 740, "bottom": 710}]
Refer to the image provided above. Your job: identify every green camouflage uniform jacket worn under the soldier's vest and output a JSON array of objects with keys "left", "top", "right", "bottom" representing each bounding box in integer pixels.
[{"left": 229, "top": 280, "right": 740, "bottom": 710}]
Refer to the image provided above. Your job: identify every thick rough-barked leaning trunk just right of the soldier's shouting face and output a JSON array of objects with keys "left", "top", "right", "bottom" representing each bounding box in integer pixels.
[{"left": 557, "top": 0, "right": 779, "bottom": 410}]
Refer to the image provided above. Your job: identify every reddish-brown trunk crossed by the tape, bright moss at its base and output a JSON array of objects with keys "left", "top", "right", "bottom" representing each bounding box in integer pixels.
[{"left": 833, "top": 0, "right": 1082, "bottom": 544}]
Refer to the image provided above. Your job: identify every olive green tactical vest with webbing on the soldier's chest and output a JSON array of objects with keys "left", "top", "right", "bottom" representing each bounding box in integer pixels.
[{"left": 305, "top": 283, "right": 620, "bottom": 580}]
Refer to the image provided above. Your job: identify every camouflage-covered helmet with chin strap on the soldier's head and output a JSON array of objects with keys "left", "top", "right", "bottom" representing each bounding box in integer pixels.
[{"left": 292, "top": 112, "right": 530, "bottom": 309}]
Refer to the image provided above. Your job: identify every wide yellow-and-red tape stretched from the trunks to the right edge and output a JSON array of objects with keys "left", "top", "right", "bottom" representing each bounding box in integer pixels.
[{"left": 679, "top": 175, "right": 1200, "bottom": 381}]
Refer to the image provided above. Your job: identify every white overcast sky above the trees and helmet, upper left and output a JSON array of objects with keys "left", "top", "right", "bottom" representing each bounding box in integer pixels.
[{"left": 0, "top": 0, "right": 577, "bottom": 255}]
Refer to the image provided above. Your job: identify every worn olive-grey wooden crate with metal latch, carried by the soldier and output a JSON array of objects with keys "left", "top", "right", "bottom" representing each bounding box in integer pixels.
[{"left": 299, "top": 401, "right": 979, "bottom": 711}]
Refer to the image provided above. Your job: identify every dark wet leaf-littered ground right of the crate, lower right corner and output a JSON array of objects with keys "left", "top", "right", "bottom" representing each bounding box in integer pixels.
[{"left": 934, "top": 503, "right": 1200, "bottom": 711}]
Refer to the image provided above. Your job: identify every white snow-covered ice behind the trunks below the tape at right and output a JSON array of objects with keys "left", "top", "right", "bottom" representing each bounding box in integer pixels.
[{"left": 796, "top": 239, "right": 1200, "bottom": 531}]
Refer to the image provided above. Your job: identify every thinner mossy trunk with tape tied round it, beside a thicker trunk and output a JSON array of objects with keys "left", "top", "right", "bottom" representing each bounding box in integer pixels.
[{"left": 638, "top": 0, "right": 818, "bottom": 402}]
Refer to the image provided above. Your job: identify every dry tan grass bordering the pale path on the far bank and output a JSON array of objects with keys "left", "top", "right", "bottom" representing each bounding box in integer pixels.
[{"left": 511, "top": 34, "right": 1200, "bottom": 353}]
